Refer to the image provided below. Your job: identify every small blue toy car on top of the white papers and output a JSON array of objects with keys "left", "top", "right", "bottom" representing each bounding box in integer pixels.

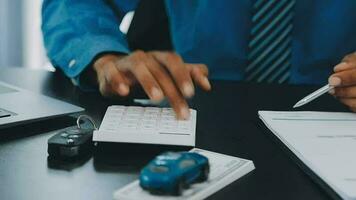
[{"left": 140, "top": 152, "right": 210, "bottom": 196}]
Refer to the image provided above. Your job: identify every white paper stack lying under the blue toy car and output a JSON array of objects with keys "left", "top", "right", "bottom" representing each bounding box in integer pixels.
[{"left": 114, "top": 148, "right": 255, "bottom": 200}]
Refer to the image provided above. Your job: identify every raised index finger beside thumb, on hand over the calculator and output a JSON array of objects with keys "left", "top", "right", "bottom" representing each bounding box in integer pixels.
[{"left": 152, "top": 52, "right": 194, "bottom": 98}]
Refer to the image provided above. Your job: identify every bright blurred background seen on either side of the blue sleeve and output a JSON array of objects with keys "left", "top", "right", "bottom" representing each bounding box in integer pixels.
[{"left": 0, "top": 0, "right": 133, "bottom": 71}]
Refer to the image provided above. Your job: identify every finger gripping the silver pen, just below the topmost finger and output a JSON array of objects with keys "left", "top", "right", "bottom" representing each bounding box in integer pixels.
[{"left": 329, "top": 68, "right": 356, "bottom": 86}]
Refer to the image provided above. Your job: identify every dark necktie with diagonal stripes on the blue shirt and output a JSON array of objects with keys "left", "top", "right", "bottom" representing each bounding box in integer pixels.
[{"left": 245, "top": 0, "right": 296, "bottom": 83}]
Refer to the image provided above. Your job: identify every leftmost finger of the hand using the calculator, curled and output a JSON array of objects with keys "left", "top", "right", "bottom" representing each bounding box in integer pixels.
[{"left": 104, "top": 62, "right": 130, "bottom": 96}]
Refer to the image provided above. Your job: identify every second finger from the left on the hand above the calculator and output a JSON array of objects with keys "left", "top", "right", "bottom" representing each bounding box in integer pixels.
[{"left": 126, "top": 51, "right": 164, "bottom": 101}]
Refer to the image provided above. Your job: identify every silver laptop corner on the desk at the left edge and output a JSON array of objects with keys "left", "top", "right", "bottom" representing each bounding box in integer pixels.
[{"left": 0, "top": 81, "right": 84, "bottom": 128}]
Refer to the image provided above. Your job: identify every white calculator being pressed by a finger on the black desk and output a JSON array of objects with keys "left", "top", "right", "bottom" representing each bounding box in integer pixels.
[{"left": 93, "top": 105, "right": 197, "bottom": 146}]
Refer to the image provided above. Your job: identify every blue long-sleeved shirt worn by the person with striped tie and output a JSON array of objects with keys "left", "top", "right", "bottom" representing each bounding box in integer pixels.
[{"left": 42, "top": 0, "right": 356, "bottom": 84}]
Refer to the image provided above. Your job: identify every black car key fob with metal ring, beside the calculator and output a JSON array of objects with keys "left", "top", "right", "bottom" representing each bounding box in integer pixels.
[{"left": 47, "top": 115, "right": 96, "bottom": 159}]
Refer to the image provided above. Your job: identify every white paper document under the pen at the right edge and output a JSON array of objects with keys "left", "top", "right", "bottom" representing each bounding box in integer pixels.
[{"left": 258, "top": 111, "right": 356, "bottom": 199}]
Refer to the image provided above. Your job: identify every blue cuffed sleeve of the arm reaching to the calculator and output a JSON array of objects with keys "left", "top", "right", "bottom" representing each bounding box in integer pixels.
[{"left": 42, "top": 0, "right": 138, "bottom": 83}]
